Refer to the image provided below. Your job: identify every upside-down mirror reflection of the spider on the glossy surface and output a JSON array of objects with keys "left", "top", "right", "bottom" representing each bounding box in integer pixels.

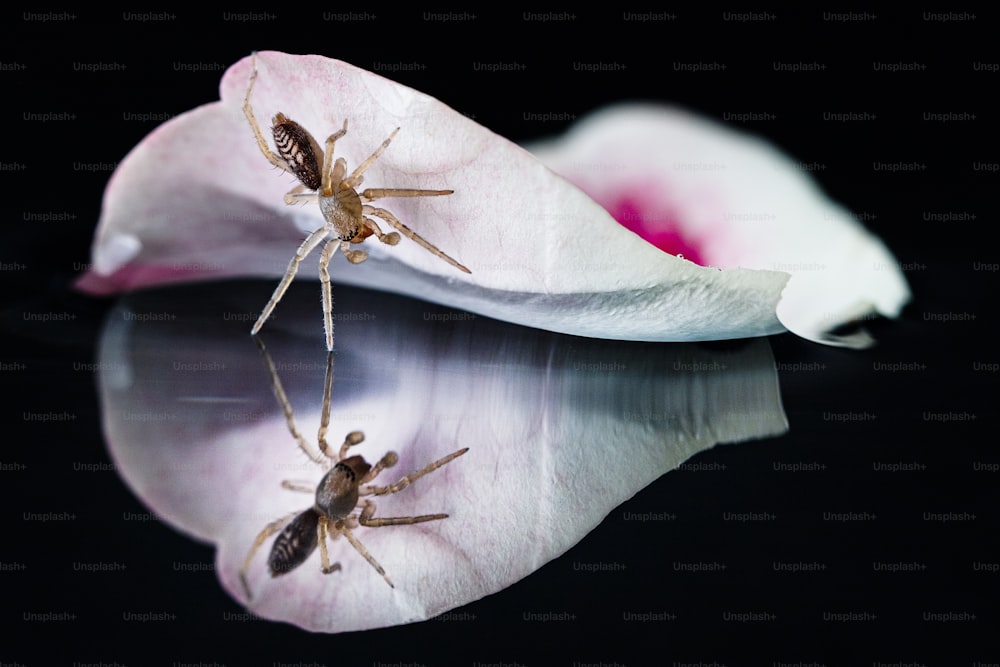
[{"left": 240, "top": 340, "right": 469, "bottom": 601}]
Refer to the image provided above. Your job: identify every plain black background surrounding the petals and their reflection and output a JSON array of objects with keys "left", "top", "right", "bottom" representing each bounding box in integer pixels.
[{"left": 0, "top": 4, "right": 1000, "bottom": 666}]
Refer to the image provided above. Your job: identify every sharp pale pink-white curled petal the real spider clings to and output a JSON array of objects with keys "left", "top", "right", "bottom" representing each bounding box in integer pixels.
[{"left": 79, "top": 53, "right": 788, "bottom": 340}]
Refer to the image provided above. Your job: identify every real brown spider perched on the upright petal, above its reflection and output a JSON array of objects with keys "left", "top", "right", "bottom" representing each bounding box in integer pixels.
[{"left": 243, "top": 54, "right": 471, "bottom": 350}]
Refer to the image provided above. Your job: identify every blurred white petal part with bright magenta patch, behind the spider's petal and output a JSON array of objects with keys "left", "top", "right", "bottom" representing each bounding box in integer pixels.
[{"left": 532, "top": 105, "right": 910, "bottom": 347}]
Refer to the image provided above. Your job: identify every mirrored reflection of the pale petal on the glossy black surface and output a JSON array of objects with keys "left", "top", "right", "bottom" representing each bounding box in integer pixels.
[{"left": 99, "top": 284, "right": 787, "bottom": 632}]
